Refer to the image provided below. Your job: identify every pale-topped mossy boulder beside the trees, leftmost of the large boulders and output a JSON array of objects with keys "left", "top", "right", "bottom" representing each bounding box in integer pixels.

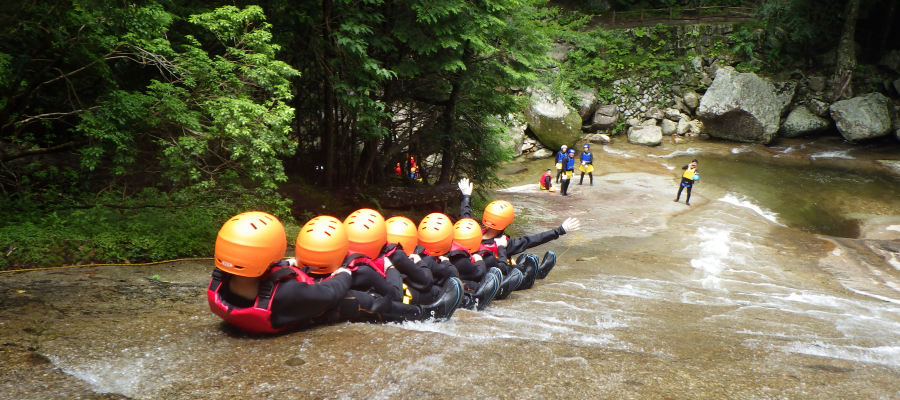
[{"left": 525, "top": 90, "right": 581, "bottom": 149}]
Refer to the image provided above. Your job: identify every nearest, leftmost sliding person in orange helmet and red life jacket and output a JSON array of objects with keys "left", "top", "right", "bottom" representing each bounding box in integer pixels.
[{"left": 207, "top": 211, "right": 460, "bottom": 333}]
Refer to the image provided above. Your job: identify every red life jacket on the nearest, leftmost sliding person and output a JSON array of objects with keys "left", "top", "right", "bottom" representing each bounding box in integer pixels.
[{"left": 206, "top": 265, "right": 318, "bottom": 333}]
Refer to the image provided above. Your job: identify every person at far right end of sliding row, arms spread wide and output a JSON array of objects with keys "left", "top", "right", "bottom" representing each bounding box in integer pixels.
[{"left": 459, "top": 178, "right": 581, "bottom": 299}]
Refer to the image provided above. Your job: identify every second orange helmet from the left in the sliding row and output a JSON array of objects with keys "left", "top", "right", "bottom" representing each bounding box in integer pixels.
[{"left": 296, "top": 215, "right": 349, "bottom": 274}]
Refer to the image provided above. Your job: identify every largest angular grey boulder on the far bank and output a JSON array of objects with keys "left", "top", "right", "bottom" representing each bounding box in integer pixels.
[{"left": 697, "top": 67, "right": 784, "bottom": 144}]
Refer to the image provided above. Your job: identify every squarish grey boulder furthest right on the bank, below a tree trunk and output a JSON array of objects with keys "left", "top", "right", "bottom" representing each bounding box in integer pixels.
[{"left": 830, "top": 93, "right": 891, "bottom": 142}]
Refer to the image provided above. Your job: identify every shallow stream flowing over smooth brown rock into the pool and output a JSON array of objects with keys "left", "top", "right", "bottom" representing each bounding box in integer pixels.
[{"left": 0, "top": 139, "right": 900, "bottom": 399}]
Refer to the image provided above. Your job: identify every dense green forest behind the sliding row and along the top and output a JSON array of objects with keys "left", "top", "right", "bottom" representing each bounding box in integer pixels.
[{"left": 0, "top": 0, "right": 897, "bottom": 270}]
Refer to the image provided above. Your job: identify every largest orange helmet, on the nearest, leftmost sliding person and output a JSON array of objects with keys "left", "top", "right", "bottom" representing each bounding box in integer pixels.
[{"left": 215, "top": 211, "right": 287, "bottom": 278}]
